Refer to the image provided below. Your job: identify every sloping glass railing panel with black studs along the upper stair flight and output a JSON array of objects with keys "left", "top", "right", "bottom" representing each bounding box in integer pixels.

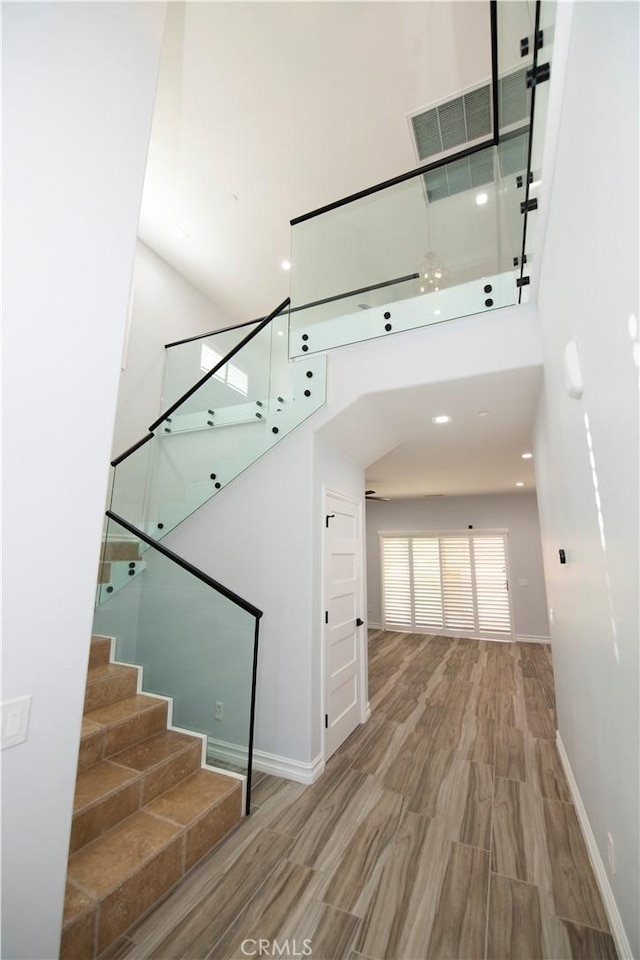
[{"left": 109, "top": 300, "right": 326, "bottom": 540}]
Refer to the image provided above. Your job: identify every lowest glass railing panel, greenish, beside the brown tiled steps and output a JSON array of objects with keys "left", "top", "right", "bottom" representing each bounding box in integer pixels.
[{"left": 94, "top": 520, "right": 256, "bottom": 800}]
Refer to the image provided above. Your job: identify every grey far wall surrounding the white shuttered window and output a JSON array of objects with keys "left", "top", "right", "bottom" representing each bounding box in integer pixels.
[{"left": 367, "top": 493, "right": 549, "bottom": 639}]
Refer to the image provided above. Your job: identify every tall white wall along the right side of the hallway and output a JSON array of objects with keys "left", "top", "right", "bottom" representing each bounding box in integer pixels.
[{"left": 535, "top": 3, "right": 640, "bottom": 957}]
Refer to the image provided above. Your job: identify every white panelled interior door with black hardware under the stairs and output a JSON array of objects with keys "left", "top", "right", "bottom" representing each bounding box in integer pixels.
[{"left": 324, "top": 493, "right": 365, "bottom": 759}]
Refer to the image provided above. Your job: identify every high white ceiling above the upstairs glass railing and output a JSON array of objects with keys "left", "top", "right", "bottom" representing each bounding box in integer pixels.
[{"left": 140, "top": 0, "right": 491, "bottom": 322}]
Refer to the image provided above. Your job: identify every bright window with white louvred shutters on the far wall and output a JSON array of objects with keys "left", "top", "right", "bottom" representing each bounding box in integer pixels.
[{"left": 381, "top": 532, "right": 513, "bottom": 639}]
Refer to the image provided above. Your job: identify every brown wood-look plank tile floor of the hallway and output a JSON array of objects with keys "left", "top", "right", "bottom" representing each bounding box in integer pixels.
[{"left": 107, "top": 632, "right": 616, "bottom": 960}]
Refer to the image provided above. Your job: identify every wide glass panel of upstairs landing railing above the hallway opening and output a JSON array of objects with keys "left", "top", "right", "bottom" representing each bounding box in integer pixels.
[{"left": 290, "top": 144, "right": 526, "bottom": 356}]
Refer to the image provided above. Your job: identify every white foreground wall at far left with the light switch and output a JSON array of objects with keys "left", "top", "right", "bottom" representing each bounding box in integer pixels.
[{"left": 2, "top": 3, "right": 164, "bottom": 960}]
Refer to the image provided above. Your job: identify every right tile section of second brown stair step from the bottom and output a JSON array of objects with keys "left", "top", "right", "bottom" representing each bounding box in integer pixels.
[{"left": 111, "top": 730, "right": 202, "bottom": 806}]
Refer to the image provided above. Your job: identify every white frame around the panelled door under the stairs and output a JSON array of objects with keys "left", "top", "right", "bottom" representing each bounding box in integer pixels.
[{"left": 318, "top": 484, "right": 370, "bottom": 759}]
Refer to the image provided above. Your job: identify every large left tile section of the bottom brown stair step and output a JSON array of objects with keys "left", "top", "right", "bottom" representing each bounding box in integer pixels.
[{"left": 63, "top": 811, "right": 185, "bottom": 960}]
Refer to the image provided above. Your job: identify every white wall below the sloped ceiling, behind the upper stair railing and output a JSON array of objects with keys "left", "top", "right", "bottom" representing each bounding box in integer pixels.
[{"left": 112, "top": 240, "right": 232, "bottom": 456}]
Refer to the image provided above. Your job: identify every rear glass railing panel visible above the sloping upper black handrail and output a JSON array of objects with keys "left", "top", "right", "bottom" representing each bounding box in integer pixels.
[{"left": 162, "top": 320, "right": 259, "bottom": 410}]
